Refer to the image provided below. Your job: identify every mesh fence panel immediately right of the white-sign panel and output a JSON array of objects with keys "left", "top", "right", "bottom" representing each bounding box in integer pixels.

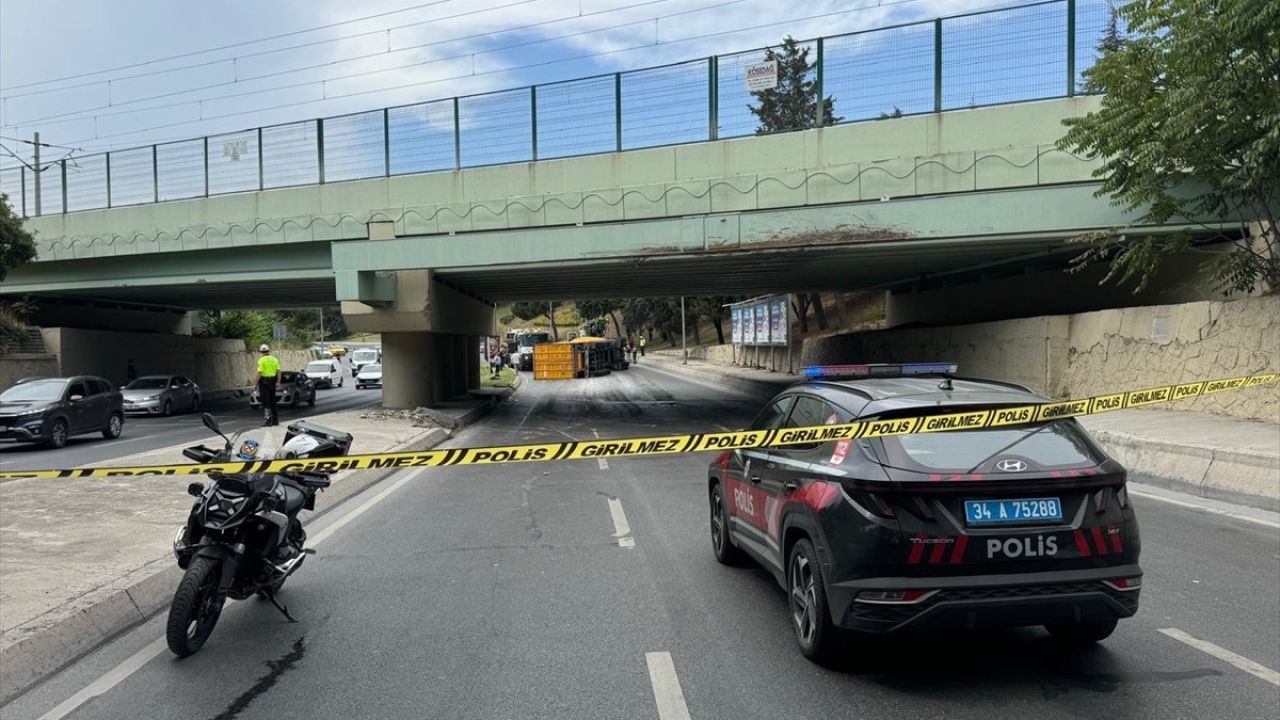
[{"left": 822, "top": 23, "right": 933, "bottom": 122}]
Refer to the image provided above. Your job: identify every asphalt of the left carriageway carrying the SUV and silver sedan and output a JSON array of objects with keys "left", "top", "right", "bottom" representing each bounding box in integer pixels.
[{"left": 0, "top": 363, "right": 383, "bottom": 470}]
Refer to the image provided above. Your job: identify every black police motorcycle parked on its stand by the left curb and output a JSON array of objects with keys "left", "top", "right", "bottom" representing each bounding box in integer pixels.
[{"left": 166, "top": 413, "right": 352, "bottom": 657}]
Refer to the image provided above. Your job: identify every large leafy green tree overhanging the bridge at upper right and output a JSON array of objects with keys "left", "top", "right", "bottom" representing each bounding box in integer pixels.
[{"left": 1059, "top": 0, "right": 1280, "bottom": 292}]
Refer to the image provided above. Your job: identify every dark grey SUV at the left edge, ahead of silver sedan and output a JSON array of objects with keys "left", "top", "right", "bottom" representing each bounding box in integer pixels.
[{"left": 0, "top": 375, "right": 124, "bottom": 447}]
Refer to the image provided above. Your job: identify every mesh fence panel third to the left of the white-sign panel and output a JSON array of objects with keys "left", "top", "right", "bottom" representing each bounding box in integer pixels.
[{"left": 458, "top": 87, "right": 534, "bottom": 168}]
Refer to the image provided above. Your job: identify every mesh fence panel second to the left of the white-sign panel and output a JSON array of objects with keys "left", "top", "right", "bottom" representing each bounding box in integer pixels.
[{"left": 538, "top": 76, "right": 618, "bottom": 158}]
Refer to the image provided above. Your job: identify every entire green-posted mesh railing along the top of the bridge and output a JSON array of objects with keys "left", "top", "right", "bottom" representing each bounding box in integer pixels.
[{"left": 0, "top": 0, "right": 1110, "bottom": 217}]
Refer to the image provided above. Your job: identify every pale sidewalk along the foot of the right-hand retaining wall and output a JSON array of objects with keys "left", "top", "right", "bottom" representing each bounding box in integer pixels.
[{"left": 645, "top": 354, "right": 1280, "bottom": 511}]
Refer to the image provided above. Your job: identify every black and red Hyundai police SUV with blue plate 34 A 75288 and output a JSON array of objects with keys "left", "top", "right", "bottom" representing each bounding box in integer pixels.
[{"left": 708, "top": 363, "right": 1142, "bottom": 661}]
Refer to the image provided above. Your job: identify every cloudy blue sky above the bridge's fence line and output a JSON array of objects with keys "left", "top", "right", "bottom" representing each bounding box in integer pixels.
[{"left": 0, "top": 0, "right": 1100, "bottom": 175}]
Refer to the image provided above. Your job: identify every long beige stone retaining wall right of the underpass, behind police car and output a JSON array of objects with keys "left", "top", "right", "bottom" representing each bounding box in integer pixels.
[{"left": 793, "top": 296, "right": 1280, "bottom": 423}]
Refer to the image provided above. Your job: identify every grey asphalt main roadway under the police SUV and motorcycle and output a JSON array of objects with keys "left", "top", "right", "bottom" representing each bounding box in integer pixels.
[{"left": 0, "top": 364, "right": 1280, "bottom": 720}]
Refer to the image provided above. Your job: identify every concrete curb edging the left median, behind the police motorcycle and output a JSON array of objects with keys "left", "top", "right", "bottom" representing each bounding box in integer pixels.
[{"left": 0, "top": 397, "right": 503, "bottom": 706}]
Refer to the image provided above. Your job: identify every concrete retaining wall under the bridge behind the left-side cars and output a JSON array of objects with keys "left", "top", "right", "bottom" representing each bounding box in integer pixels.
[{"left": 41, "top": 328, "right": 311, "bottom": 396}]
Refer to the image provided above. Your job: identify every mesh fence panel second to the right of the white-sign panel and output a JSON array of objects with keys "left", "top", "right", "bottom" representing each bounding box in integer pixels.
[{"left": 942, "top": 3, "right": 1068, "bottom": 110}]
